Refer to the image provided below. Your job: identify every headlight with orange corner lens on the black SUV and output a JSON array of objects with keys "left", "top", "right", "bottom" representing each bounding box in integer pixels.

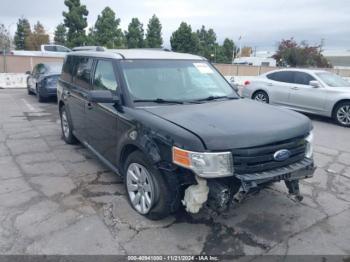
[{"left": 173, "top": 147, "right": 233, "bottom": 178}]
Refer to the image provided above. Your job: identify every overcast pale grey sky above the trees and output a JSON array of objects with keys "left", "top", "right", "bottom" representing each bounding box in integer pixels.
[{"left": 0, "top": 0, "right": 350, "bottom": 51}]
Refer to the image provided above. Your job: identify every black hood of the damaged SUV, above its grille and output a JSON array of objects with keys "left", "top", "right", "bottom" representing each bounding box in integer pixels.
[{"left": 143, "top": 99, "right": 312, "bottom": 150}]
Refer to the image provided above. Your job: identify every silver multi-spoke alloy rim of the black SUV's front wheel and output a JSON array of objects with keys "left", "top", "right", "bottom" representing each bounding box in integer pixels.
[{"left": 126, "top": 163, "right": 154, "bottom": 214}]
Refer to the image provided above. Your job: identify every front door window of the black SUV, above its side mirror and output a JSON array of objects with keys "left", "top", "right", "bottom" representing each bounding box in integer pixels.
[{"left": 93, "top": 60, "right": 118, "bottom": 91}]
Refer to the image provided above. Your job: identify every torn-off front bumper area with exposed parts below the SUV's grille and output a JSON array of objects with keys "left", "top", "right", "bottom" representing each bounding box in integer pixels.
[{"left": 183, "top": 158, "right": 316, "bottom": 213}]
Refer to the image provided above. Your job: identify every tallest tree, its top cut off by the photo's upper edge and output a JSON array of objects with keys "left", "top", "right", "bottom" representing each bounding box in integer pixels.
[{"left": 63, "top": 0, "right": 89, "bottom": 47}]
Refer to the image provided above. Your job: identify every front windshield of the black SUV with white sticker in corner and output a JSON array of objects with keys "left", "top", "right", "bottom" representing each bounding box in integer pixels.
[{"left": 121, "top": 60, "right": 238, "bottom": 101}]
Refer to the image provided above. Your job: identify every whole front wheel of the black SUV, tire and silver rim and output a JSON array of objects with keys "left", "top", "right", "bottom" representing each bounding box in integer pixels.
[{"left": 124, "top": 151, "right": 180, "bottom": 220}]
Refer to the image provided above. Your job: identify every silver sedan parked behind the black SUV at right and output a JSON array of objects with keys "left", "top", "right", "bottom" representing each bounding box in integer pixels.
[{"left": 242, "top": 69, "right": 350, "bottom": 127}]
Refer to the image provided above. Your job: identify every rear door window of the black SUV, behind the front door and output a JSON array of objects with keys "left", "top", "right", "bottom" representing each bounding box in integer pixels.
[{"left": 74, "top": 57, "right": 93, "bottom": 89}]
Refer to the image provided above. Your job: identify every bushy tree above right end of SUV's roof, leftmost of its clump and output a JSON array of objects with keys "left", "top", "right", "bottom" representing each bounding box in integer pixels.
[{"left": 170, "top": 22, "right": 199, "bottom": 54}]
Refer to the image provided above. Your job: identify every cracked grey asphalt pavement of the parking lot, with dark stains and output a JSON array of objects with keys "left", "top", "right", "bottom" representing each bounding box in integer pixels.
[{"left": 0, "top": 89, "right": 350, "bottom": 259}]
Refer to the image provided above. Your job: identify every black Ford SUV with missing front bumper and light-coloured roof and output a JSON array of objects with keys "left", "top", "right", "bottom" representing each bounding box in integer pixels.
[{"left": 57, "top": 49, "right": 314, "bottom": 219}]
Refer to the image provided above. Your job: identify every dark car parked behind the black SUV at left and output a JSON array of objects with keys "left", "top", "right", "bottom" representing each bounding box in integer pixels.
[{"left": 27, "top": 62, "right": 62, "bottom": 102}]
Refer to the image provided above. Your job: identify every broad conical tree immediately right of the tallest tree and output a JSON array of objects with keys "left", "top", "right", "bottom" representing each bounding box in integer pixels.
[{"left": 91, "top": 7, "right": 124, "bottom": 48}]
